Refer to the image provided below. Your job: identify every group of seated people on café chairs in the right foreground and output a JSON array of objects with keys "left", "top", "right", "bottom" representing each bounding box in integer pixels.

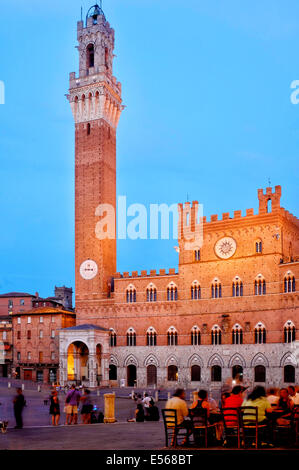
[{"left": 166, "top": 385, "right": 299, "bottom": 447}]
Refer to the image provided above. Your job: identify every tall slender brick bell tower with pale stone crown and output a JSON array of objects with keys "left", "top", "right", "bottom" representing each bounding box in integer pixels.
[{"left": 68, "top": 5, "right": 123, "bottom": 313}]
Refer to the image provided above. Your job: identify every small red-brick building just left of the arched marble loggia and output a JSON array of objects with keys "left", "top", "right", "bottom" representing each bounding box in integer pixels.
[{"left": 12, "top": 306, "right": 76, "bottom": 383}]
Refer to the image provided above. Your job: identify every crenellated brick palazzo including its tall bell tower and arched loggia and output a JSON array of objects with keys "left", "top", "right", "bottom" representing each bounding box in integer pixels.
[{"left": 60, "top": 5, "right": 299, "bottom": 390}]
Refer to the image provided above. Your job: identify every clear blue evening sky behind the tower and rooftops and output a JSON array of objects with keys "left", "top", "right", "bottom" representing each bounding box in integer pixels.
[{"left": 0, "top": 0, "right": 299, "bottom": 296}]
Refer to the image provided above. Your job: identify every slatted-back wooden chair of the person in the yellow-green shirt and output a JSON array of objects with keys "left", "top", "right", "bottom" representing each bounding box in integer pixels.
[{"left": 240, "top": 406, "right": 268, "bottom": 449}]
